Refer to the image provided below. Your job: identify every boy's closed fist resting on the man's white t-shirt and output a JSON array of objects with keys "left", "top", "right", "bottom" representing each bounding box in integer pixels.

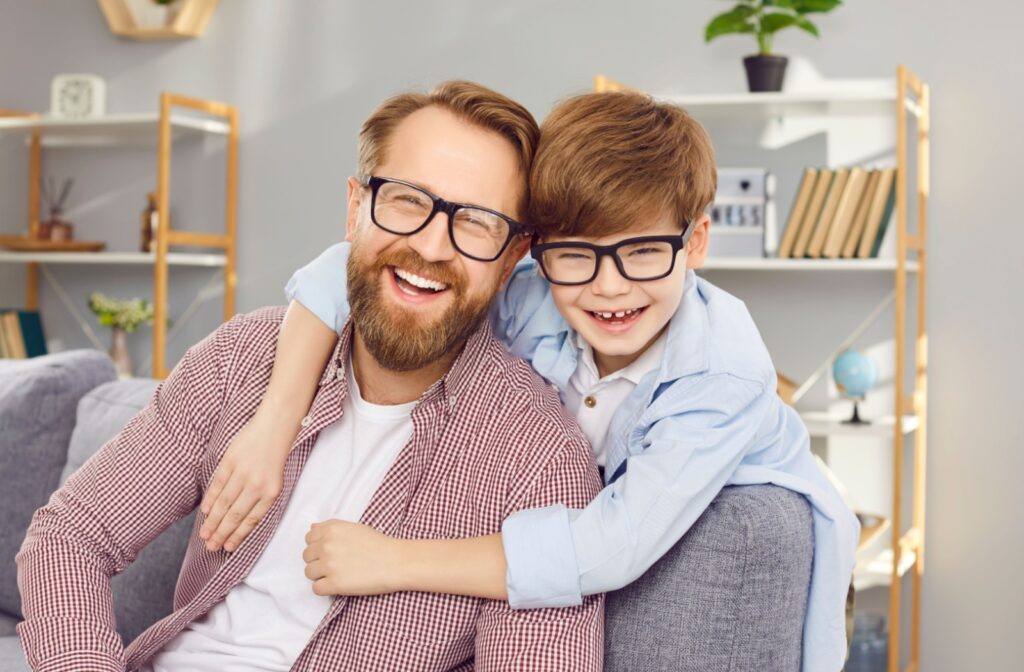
[{"left": 302, "top": 520, "right": 408, "bottom": 595}]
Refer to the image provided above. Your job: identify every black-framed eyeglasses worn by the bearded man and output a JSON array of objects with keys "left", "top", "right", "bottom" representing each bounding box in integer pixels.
[{"left": 360, "top": 175, "right": 526, "bottom": 261}]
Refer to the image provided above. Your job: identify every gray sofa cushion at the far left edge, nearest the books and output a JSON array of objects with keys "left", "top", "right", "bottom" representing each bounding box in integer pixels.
[{"left": 0, "top": 350, "right": 117, "bottom": 617}]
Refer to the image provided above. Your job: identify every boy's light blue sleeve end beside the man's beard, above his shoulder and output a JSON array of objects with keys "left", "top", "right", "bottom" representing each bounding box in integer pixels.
[{"left": 285, "top": 243, "right": 350, "bottom": 333}]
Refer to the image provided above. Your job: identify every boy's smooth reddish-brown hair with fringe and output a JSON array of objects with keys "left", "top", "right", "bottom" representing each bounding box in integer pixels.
[{"left": 527, "top": 92, "right": 718, "bottom": 238}]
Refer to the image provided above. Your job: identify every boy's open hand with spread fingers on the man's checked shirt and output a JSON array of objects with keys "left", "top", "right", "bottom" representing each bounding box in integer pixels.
[{"left": 199, "top": 412, "right": 297, "bottom": 551}]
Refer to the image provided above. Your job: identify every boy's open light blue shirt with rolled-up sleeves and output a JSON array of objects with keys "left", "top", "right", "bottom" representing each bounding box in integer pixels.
[{"left": 286, "top": 243, "right": 859, "bottom": 671}]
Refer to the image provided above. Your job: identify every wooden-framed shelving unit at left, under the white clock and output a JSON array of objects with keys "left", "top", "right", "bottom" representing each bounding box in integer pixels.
[{"left": 0, "top": 91, "right": 239, "bottom": 379}]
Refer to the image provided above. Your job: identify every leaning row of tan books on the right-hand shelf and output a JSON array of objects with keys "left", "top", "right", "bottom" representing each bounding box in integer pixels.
[{"left": 778, "top": 168, "right": 896, "bottom": 259}]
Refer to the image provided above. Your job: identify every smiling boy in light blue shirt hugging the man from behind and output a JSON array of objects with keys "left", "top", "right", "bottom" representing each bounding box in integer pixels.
[{"left": 203, "top": 93, "right": 859, "bottom": 671}]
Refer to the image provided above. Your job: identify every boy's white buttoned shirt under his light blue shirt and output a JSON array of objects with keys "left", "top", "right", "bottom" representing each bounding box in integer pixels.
[{"left": 563, "top": 333, "right": 666, "bottom": 467}]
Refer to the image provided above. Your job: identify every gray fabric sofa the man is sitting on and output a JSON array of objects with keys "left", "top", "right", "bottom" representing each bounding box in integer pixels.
[{"left": 0, "top": 350, "right": 813, "bottom": 672}]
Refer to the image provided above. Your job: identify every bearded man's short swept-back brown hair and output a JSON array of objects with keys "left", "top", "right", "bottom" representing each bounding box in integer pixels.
[{"left": 357, "top": 80, "right": 541, "bottom": 215}]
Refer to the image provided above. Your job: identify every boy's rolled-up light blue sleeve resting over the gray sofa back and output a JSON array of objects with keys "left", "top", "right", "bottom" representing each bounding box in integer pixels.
[{"left": 502, "top": 374, "right": 775, "bottom": 608}]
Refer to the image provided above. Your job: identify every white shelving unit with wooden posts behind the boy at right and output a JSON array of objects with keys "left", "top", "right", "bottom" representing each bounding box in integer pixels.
[{"left": 594, "top": 67, "right": 930, "bottom": 672}]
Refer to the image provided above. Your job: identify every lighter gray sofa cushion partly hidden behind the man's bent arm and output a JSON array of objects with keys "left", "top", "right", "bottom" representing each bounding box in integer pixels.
[{"left": 63, "top": 378, "right": 196, "bottom": 644}]
